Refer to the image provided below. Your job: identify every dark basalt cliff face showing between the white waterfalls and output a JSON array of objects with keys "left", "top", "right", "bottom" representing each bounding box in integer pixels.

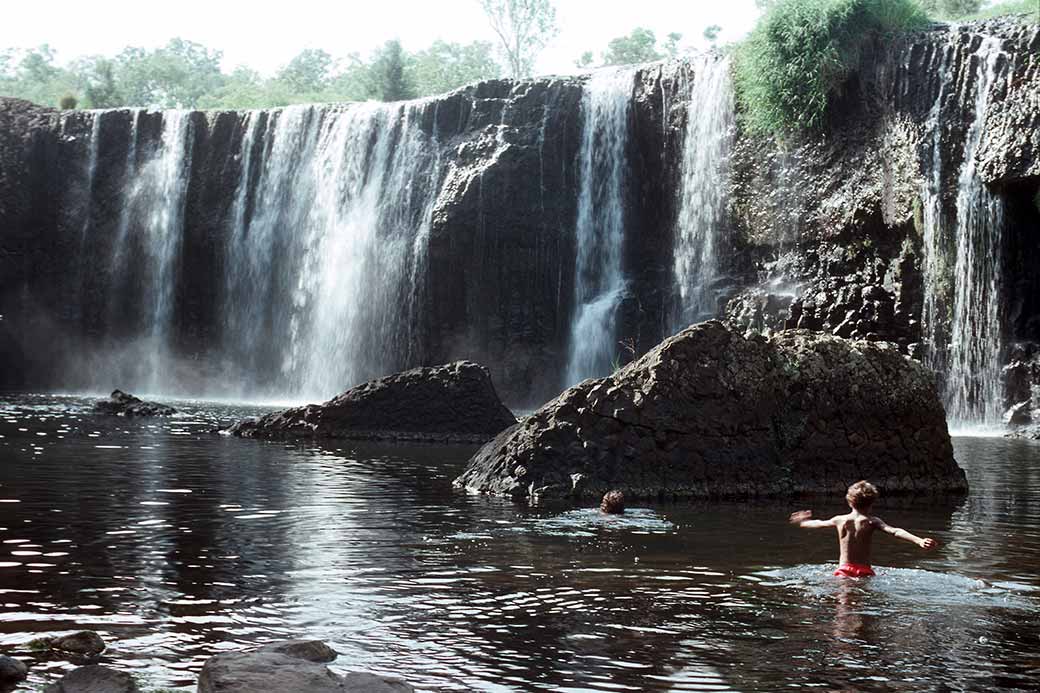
[{"left": 0, "top": 19, "right": 1040, "bottom": 406}]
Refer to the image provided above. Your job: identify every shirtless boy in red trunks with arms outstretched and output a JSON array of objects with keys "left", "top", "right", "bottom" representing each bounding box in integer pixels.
[{"left": 790, "top": 481, "right": 939, "bottom": 578}]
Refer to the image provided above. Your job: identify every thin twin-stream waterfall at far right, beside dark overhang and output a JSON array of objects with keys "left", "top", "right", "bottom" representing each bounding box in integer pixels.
[{"left": 922, "top": 34, "right": 1004, "bottom": 426}]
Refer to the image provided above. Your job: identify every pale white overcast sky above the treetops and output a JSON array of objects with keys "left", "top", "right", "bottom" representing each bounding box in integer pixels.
[{"left": 0, "top": 0, "right": 758, "bottom": 75}]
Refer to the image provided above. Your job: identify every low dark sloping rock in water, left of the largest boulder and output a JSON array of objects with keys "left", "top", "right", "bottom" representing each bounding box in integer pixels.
[{"left": 229, "top": 361, "right": 516, "bottom": 442}]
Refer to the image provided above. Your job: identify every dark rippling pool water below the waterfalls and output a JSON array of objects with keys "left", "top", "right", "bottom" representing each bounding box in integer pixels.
[{"left": 0, "top": 395, "right": 1040, "bottom": 691}]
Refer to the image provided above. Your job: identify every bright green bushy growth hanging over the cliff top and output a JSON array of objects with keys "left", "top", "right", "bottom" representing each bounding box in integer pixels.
[{"left": 735, "top": 0, "right": 929, "bottom": 136}]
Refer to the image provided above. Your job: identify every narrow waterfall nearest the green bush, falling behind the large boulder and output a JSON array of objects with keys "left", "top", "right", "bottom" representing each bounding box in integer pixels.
[{"left": 674, "top": 55, "right": 734, "bottom": 329}]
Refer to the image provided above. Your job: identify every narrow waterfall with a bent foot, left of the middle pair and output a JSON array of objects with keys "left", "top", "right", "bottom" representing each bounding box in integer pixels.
[{"left": 567, "top": 70, "right": 633, "bottom": 384}]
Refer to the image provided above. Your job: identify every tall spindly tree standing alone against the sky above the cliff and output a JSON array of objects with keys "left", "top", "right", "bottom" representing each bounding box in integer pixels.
[{"left": 480, "top": 0, "right": 558, "bottom": 79}]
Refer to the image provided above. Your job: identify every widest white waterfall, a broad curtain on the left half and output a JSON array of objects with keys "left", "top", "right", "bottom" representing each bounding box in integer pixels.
[{"left": 224, "top": 102, "right": 440, "bottom": 399}]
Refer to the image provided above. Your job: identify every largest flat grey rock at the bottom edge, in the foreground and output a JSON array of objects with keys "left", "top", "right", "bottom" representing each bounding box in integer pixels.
[{"left": 199, "top": 640, "right": 415, "bottom": 693}]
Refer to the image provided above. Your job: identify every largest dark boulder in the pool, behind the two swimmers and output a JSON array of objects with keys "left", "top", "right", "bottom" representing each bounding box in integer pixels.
[{"left": 456, "top": 322, "right": 967, "bottom": 501}]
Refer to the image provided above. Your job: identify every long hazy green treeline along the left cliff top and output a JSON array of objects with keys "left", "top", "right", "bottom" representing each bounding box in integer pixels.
[{"left": 0, "top": 39, "right": 502, "bottom": 108}]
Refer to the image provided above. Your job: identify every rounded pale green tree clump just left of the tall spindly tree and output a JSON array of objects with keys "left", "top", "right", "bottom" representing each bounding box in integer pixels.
[{"left": 411, "top": 41, "right": 502, "bottom": 96}]
